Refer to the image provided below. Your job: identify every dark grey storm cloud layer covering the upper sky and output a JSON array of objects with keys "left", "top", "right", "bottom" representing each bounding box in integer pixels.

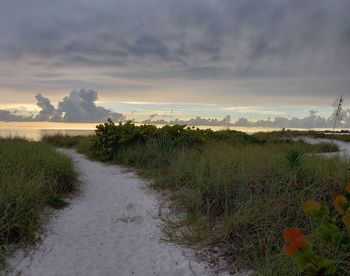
[{"left": 0, "top": 0, "right": 350, "bottom": 101}]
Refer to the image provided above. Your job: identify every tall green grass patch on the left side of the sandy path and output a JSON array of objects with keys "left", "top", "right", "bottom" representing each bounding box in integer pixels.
[{"left": 0, "top": 138, "right": 77, "bottom": 266}]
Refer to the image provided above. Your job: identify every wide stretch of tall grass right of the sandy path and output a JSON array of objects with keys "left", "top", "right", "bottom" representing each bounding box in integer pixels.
[{"left": 46, "top": 124, "right": 350, "bottom": 275}]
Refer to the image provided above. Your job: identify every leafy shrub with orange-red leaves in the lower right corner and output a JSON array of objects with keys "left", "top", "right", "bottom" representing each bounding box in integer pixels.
[{"left": 284, "top": 182, "right": 350, "bottom": 276}]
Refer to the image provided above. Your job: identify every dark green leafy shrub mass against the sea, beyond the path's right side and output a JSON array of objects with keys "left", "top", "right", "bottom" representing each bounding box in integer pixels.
[{"left": 93, "top": 120, "right": 254, "bottom": 161}]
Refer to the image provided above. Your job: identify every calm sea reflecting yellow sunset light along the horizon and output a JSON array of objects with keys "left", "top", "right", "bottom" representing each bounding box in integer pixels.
[{"left": 0, "top": 122, "right": 348, "bottom": 141}]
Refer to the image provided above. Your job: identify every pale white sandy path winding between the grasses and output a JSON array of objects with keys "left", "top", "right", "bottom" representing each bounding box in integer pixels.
[{"left": 5, "top": 150, "right": 224, "bottom": 276}]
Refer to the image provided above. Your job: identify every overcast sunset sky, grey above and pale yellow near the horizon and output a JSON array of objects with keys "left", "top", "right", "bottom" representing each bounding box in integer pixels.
[{"left": 0, "top": 0, "right": 350, "bottom": 124}]
